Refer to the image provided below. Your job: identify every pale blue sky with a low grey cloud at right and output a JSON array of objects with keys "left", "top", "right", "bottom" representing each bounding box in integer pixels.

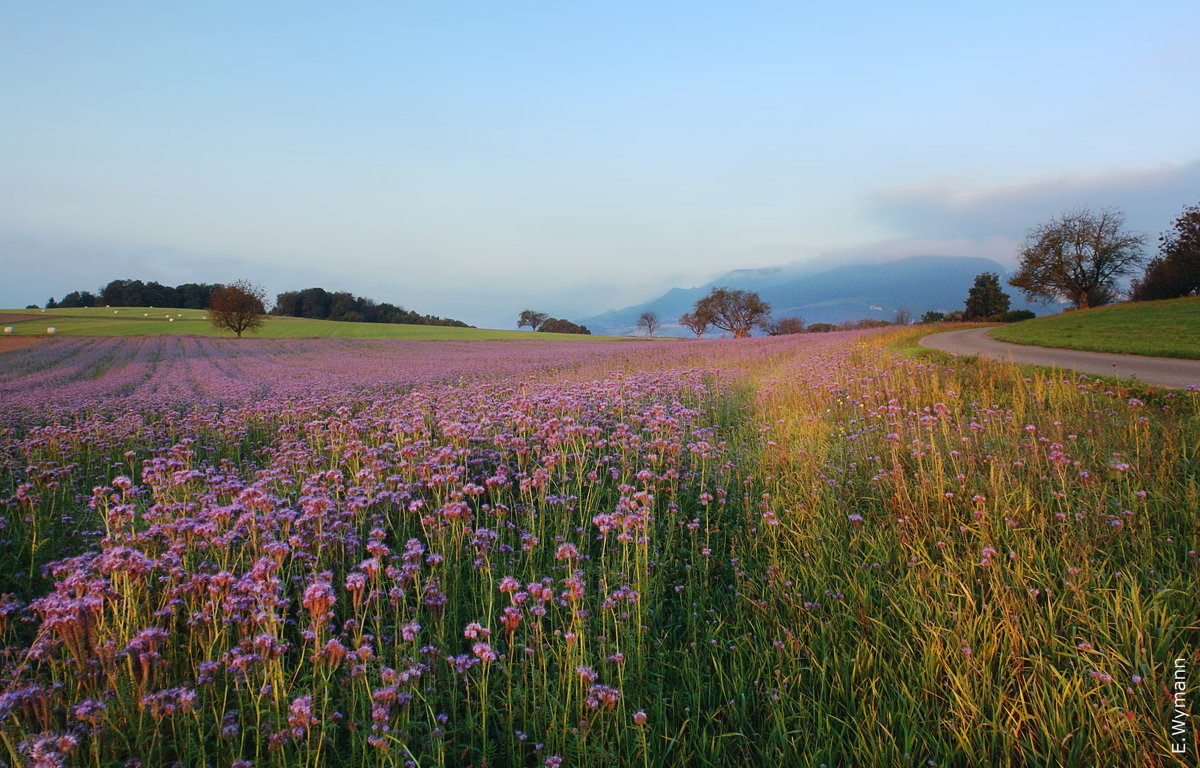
[{"left": 0, "top": 0, "right": 1200, "bottom": 326}]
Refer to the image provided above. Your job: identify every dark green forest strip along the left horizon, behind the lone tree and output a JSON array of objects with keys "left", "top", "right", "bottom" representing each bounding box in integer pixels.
[{"left": 46, "top": 280, "right": 474, "bottom": 328}]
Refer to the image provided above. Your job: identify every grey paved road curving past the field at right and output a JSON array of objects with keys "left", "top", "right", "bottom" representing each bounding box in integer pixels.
[{"left": 920, "top": 328, "right": 1200, "bottom": 389}]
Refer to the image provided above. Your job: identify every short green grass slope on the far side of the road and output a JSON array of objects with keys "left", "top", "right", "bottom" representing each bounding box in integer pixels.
[{"left": 990, "top": 296, "right": 1200, "bottom": 359}]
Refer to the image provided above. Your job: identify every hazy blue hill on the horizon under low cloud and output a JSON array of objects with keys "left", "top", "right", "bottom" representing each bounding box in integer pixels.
[{"left": 581, "top": 256, "right": 1045, "bottom": 336}]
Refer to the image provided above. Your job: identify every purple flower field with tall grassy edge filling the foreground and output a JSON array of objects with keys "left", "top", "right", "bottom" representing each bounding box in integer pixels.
[{"left": 0, "top": 328, "right": 1200, "bottom": 768}]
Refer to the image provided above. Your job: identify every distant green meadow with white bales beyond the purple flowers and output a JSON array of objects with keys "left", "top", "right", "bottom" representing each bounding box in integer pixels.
[{"left": 0, "top": 307, "right": 635, "bottom": 341}]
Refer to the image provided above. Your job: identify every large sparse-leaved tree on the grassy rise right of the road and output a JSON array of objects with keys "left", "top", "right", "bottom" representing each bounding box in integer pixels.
[{"left": 1008, "top": 208, "right": 1145, "bottom": 310}]
